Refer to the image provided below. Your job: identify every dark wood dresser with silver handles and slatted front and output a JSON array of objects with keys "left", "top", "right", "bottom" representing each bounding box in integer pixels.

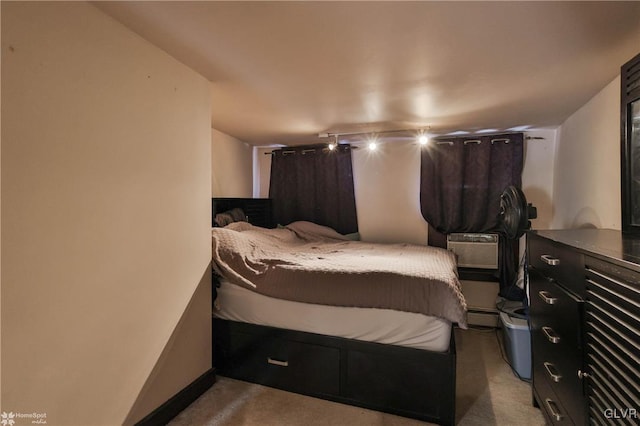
[{"left": 527, "top": 229, "right": 640, "bottom": 425}]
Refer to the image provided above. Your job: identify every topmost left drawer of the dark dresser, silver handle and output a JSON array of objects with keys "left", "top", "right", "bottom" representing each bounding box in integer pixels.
[{"left": 528, "top": 235, "right": 584, "bottom": 296}]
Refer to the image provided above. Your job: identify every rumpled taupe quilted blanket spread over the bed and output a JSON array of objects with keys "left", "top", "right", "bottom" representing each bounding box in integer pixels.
[{"left": 212, "top": 222, "right": 467, "bottom": 328}]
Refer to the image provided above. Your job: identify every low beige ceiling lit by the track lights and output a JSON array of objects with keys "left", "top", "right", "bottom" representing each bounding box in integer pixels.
[{"left": 94, "top": 1, "right": 640, "bottom": 145}]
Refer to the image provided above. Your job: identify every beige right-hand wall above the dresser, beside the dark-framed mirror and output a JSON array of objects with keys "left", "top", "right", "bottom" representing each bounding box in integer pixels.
[{"left": 551, "top": 77, "right": 621, "bottom": 229}]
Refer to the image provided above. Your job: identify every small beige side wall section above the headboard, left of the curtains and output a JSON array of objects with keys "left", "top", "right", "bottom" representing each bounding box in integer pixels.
[{"left": 211, "top": 129, "right": 253, "bottom": 198}]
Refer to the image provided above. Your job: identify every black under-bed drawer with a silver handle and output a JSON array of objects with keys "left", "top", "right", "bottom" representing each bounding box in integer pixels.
[{"left": 216, "top": 326, "right": 340, "bottom": 396}]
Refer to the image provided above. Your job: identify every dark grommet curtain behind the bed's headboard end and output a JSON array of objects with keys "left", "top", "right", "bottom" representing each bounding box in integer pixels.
[{"left": 269, "top": 145, "right": 358, "bottom": 234}]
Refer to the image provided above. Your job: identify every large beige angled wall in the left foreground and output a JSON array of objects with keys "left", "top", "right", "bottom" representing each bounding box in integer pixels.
[{"left": 1, "top": 2, "right": 211, "bottom": 425}]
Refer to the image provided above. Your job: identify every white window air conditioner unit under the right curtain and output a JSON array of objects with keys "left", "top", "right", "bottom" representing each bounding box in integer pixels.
[{"left": 447, "top": 233, "right": 498, "bottom": 269}]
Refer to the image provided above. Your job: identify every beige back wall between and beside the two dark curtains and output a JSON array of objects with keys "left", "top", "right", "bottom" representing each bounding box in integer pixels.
[{"left": 254, "top": 134, "right": 556, "bottom": 244}]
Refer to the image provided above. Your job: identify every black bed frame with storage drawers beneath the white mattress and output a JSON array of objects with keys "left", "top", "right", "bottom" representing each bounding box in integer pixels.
[{"left": 213, "top": 199, "right": 456, "bottom": 425}]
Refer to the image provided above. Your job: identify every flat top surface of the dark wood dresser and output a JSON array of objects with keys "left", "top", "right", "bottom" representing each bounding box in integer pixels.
[{"left": 529, "top": 229, "right": 640, "bottom": 270}]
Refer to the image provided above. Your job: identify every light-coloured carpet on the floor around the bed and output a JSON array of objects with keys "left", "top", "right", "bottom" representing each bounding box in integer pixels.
[{"left": 169, "top": 329, "right": 545, "bottom": 426}]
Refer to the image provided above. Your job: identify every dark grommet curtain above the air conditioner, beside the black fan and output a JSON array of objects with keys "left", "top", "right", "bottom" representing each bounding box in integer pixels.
[{"left": 420, "top": 133, "right": 524, "bottom": 294}]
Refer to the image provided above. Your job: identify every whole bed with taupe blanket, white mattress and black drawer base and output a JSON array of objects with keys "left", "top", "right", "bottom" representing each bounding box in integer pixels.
[{"left": 212, "top": 199, "right": 466, "bottom": 425}]
